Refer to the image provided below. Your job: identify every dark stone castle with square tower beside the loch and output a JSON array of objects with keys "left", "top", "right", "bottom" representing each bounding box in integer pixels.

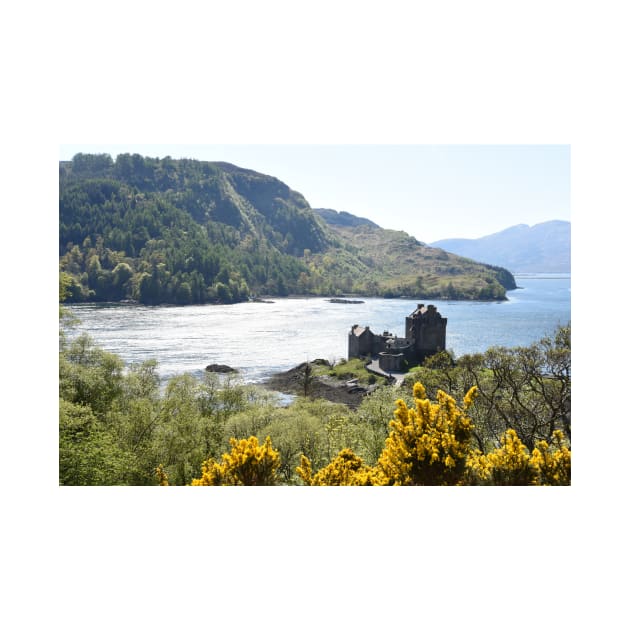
[{"left": 348, "top": 304, "right": 446, "bottom": 372}]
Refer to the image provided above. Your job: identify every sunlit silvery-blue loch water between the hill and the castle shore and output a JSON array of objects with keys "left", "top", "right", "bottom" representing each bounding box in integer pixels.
[{"left": 69, "top": 274, "right": 571, "bottom": 383}]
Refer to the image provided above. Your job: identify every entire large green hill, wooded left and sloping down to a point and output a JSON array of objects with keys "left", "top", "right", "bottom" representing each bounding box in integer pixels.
[{"left": 59, "top": 154, "right": 513, "bottom": 304}]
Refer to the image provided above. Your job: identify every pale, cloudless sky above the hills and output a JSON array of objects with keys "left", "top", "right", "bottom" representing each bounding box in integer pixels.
[{"left": 59, "top": 144, "right": 571, "bottom": 243}]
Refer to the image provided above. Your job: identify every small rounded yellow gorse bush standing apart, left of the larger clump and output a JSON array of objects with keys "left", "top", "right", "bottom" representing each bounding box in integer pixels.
[{"left": 191, "top": 436, "right": 280, "bottom": 486}]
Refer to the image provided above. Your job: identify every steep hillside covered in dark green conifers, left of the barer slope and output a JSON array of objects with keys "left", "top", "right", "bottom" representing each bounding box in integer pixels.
[{"left": 59, "top": 155, "right": 334, "bottom": 304}]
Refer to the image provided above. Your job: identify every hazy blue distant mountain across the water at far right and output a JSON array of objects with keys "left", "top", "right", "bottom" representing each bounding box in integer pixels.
[{"left": 431, "top": 221, "right": 571, "bottom": 273}]
